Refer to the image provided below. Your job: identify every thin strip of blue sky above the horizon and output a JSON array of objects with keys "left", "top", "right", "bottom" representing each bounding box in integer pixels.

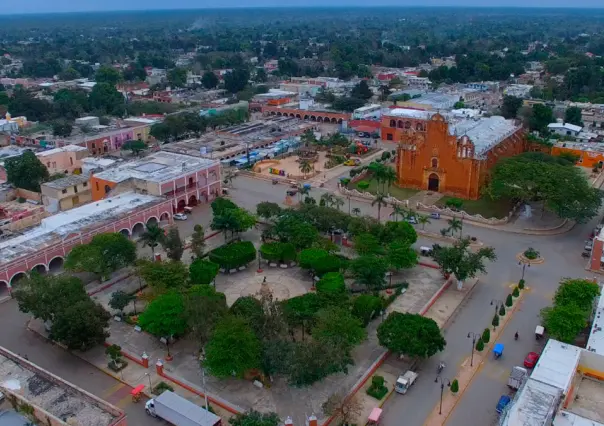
[{"left": 0, "top": 0, "right": 604, "bottom": 14}]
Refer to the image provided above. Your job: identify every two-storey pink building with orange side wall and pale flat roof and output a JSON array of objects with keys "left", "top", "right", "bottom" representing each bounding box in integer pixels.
[{"left": 90, "top": 151, "right": 222, "bottom": 211}]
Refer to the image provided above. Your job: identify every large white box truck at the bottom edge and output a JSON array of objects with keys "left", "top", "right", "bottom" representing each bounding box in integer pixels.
[{"left": 145, "top": 390, "right": 222, "bottom": 426}]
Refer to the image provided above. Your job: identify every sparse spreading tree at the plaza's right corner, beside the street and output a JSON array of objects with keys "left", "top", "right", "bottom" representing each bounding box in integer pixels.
[{"left": 432, "top": 238, "right": 497, "bottom": 288}]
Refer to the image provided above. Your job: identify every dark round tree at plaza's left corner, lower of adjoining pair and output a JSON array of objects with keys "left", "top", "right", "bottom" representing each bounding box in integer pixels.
[{"left": 49, "top": 299, "right": 111, "bottom": 351}]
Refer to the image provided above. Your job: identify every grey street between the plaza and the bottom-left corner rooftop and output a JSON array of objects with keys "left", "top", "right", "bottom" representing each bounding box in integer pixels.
[{"left": 0, "top": 300, "right": 164, "bottom": 426}]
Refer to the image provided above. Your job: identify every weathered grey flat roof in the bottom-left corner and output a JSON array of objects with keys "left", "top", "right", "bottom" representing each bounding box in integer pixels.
[{"left": 0, "top": 348, "right": 124, "bottom": 426}]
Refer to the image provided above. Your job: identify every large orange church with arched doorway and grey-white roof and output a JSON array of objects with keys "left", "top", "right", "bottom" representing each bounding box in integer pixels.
[{"left": 381, "top": 108, "right": 526, "bottom": 200}]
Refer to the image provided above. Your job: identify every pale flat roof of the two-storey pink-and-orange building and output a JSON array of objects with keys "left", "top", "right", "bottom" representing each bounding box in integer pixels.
[{"left": 94, "top": 151, "right": 217, "bottom": 183}]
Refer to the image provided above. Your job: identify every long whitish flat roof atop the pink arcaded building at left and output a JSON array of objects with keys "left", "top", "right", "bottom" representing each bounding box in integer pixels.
[{"left": 0, "top": 192, "right": 164, "bottom": 265}]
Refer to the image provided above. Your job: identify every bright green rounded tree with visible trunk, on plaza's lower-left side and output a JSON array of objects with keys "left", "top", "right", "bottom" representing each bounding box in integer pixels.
[{"left": 138, "top": 291, "right": 187, "bottom": 356}]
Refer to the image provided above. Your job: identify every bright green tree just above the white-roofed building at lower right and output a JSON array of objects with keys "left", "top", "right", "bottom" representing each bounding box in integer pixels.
[{"left": 541, "top": 304, "right": 587, "bottom": 343}]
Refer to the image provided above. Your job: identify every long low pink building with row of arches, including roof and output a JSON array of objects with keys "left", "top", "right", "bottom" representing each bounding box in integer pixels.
[{"left": 0, "top": 192, "right": 172, "bottom": 291}]
